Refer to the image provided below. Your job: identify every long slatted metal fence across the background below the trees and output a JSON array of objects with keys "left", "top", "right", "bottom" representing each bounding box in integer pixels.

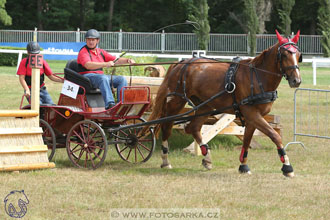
[{"left": 0, "top": 29, "right": 323, "bottom": 55}]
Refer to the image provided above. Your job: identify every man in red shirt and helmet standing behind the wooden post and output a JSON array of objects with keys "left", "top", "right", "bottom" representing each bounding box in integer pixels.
[{"left": 17, "top": 42, "right": 63, "bottom": 104}]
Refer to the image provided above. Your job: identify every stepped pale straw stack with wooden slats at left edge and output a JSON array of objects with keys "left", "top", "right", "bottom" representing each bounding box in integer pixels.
[{"left": 0, "top": 111, "right": 55, "bottom": 171}]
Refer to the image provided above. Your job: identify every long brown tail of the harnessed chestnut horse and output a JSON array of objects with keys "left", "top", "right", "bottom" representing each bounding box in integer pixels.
[{"left": 142, "top": 64, "right": 175, "bottom": 135}]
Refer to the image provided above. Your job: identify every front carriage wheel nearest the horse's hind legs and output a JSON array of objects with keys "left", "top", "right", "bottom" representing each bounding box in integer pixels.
[{"left": 115, "top": 118, "right": 156, "bottom": 163}]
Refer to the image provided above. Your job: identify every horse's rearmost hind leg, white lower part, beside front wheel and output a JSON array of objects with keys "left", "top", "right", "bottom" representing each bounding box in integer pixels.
[{"left": 160, "top": 96, "right": 185, "bottom": 169}]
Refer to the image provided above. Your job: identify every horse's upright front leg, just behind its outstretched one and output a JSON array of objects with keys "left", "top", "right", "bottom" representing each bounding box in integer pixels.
[{"left": 238, "top": 124, "right": 255, "bottom": 174}]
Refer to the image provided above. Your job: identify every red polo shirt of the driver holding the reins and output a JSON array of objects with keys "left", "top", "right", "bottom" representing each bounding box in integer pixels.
[{"left": 77, "top": 47, "right": 116, "bottom": 74}]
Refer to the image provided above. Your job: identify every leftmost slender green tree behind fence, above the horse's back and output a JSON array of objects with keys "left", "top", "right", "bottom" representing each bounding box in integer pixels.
[{"left": 188, "top": 0, "right": 210, "bottom": 50}]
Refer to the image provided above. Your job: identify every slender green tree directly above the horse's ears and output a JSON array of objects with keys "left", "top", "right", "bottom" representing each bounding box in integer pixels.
[{"left": 277, "top": 0, "right": 295, "bottom": 36}]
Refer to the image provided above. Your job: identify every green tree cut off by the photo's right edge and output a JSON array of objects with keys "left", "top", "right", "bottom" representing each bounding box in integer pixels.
[{"left": 317, "top": 0, "right": 330, "bottom": 57}]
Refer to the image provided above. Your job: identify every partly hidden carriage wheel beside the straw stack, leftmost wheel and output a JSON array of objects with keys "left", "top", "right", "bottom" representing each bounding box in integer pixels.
[{"left": 39, "top": 119, "right": 56, "bottom": 161}]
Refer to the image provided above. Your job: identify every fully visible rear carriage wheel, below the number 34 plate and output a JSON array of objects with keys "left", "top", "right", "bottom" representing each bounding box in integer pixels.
[{"left": 66, "top": 120, "right": 108, "bottom": 169}]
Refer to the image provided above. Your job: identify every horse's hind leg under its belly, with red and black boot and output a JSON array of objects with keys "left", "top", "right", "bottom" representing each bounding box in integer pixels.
[{"left": 185, "top": 116, "right": 212, "bottom": 170}]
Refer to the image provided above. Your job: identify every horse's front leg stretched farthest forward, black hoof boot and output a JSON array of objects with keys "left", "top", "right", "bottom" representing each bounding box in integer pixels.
[{"left": 251, "top": 115, "right": 294, "bottom": 177}]
